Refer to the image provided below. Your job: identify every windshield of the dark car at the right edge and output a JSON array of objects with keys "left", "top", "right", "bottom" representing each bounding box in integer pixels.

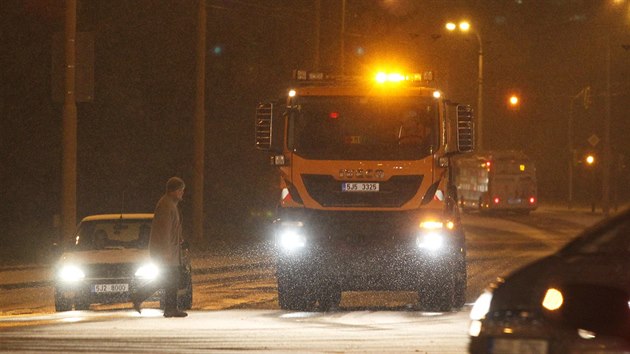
[{"left": 563, "top": 213, "right": 630, "bottom": 257}]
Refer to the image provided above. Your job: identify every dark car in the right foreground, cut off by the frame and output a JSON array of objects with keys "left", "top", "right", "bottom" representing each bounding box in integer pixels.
[{"left": 469, "top": 209, "right": 630, "bottom": 354}]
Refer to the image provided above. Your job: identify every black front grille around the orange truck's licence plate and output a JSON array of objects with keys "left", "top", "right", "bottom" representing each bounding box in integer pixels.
[{"left": 302, "top": 174, "right": 423, "bottom": 208}]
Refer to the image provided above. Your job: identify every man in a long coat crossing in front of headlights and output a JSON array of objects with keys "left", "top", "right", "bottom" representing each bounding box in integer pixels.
[{"left": 132, "top": 177, "right": 188, "bottom": 317}]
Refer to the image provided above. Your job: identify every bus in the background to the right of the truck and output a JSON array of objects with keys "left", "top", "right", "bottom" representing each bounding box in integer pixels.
[{"left": 454, "top": 150, "right": 538, "bottom": 214}]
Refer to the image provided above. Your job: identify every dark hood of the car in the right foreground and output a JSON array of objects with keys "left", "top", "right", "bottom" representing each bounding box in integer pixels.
[{"left": 490, "top": 254, "right": 630, "bottom": 311}]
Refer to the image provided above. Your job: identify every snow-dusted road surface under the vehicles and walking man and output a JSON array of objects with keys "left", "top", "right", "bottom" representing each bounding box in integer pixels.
[{"left": 0, "top": 209, "right": 601, "bottom": 353}]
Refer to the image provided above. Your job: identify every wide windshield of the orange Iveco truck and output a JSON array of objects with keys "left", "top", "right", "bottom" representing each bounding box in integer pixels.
[{"left": 289, "top": 96, "right": 438, "bottom": 160}]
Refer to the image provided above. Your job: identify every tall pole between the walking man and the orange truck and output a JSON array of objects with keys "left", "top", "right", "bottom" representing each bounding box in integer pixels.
[{"left": 192, "top": 0, "right": 207, "bottom": 242}]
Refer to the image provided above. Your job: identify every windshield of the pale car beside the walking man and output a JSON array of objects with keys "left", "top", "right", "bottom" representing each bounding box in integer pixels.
[{"left": 75, "top": 219, "right": 151, "bottom": 251}]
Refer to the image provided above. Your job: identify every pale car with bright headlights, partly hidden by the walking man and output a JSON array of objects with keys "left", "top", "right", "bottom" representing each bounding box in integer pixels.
[{"left": 54, "top": 214, "right": 193, "bottom": 311}]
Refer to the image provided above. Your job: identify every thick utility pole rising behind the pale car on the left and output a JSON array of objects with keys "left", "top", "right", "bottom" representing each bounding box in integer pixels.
[{"left": 61, "top": 0, "right": 77, "bottom": 242}]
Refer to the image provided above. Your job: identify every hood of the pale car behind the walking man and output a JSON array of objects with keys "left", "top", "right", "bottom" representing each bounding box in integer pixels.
[{"left": 59, "top": 248, "right": 150, "bottom": 264}]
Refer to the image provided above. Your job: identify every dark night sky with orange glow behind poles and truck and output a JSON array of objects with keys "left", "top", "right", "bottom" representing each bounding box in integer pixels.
[{"left": 0, "top": 0, "right": 630, "bottom": 262}]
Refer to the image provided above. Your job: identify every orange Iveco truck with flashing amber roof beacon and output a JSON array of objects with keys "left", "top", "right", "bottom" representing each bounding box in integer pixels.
[{"left": 255, "top": 71, "right": 474, "bottom": 311}]
